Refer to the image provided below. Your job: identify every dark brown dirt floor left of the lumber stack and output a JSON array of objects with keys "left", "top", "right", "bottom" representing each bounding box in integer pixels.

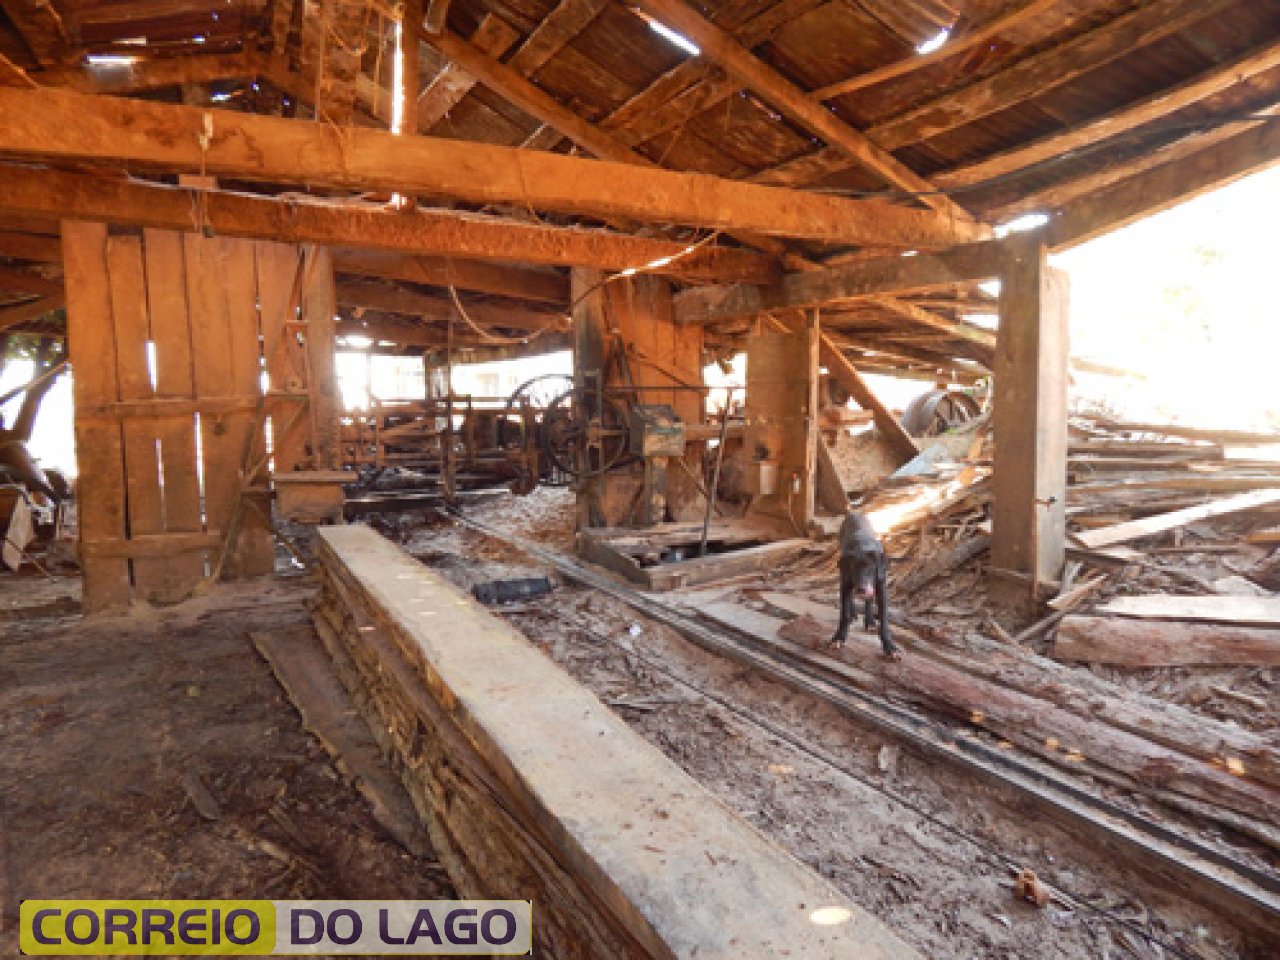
[{"left": 0, "top": 576, "right": 452, "bottom": 956}]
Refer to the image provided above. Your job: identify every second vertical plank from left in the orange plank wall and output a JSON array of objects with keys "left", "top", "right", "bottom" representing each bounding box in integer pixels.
[{"left": 106, "top": 237, "right": 168, "bottom": 600}]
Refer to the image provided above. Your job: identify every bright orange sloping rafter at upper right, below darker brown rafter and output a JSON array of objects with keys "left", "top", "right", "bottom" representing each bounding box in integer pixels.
[{"left": 934, "top": 42, "right": 1280, "bottom": 187}]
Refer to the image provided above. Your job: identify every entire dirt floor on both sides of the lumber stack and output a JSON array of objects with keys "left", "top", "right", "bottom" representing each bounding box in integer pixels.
[{"left": 0, "top": 489, "right": 1275, "bottom": 960}]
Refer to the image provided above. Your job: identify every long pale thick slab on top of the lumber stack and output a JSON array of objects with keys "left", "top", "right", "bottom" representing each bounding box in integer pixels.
[{"left": 317, "top": 526, "right": 916, "bottom": 960}]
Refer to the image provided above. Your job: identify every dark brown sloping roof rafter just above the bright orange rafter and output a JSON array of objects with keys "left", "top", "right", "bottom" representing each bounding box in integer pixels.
[{"left": 867, "top": 0, "right": 1233, "bottom": 150}]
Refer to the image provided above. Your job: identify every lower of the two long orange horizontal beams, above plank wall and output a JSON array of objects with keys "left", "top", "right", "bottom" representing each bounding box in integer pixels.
[{"left": 0, "top": 165, "right": 777, "bottom": 280}]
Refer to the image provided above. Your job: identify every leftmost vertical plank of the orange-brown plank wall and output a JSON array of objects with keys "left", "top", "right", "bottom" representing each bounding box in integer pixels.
[{"left": 63, "top": 221, "right": 129, "bottom": 613}]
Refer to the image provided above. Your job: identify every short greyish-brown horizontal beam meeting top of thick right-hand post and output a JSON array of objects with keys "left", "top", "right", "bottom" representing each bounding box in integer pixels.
[{"left": 676, "top": 241, "right": 1005, "bottom": 324}]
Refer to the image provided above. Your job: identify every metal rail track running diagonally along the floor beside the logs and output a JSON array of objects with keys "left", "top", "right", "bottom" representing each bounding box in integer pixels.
[{"left": 451, "top": 512, "right": 1280, "bottom": 934}]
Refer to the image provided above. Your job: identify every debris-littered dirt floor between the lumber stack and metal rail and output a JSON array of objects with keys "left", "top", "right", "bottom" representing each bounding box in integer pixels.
[{"left": 393, "top": 490, "right": 1274, "bottom": 959}]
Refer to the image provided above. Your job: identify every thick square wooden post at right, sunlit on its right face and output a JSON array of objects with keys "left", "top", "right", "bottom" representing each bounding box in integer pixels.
[{"left": 991, "top": 234, "right": 1068, "bottom": 600}]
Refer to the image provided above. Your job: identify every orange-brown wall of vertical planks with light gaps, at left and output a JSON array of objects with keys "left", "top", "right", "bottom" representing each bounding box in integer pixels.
[{"left": 63, "top": 221, "right": 337, "bottom": 611}]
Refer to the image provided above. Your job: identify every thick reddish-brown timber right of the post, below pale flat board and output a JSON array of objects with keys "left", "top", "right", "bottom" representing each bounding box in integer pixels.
[{"left": 1053, "top": 616, "right": 1280, "bottom": 668}]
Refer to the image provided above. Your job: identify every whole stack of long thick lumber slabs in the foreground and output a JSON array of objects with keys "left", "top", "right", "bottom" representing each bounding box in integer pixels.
[{"left": 316, "top": 526, "right": 918, "bottom": 960}]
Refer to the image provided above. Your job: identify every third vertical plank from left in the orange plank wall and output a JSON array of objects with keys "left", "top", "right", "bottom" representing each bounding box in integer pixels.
[{"left": 142, "top": 230, "right": 205, "bottom": 602}]
